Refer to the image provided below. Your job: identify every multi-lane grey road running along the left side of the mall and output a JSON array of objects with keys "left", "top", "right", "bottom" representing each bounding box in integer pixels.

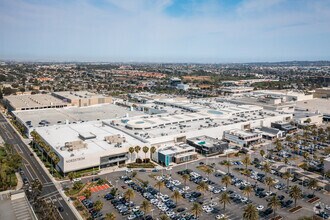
[{"left": 0, "top": 113, "right": 77, "bottom": 220}]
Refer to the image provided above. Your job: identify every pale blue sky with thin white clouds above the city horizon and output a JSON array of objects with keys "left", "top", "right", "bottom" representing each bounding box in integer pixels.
[{"left": 0, "top": 0, "right": 330, "bottom": 63}]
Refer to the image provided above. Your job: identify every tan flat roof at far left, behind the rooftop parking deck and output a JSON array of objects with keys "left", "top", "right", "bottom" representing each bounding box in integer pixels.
[{"left": 4, "top": 94, "right": 68, "bottom": 109}]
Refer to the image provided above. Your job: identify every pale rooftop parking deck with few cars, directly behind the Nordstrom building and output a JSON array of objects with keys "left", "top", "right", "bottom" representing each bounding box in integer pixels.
[{"left": 13, "top": 104, "right": 145, "bottom": 128}]
